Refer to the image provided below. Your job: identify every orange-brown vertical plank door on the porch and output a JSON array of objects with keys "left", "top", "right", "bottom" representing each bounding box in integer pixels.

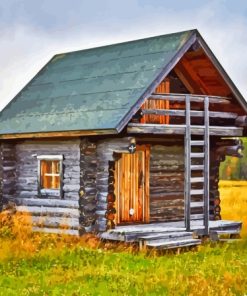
[{"left": 115, "top": 146, "right": 149, "bottom": 224}]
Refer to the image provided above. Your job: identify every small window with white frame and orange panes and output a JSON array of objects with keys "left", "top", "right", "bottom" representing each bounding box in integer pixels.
[{"left": 37, "top": 155, "right": 63, "bottom": 197}]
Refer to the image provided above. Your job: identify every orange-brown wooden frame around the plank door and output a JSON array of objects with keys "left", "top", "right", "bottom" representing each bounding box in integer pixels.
[{"left": 114, "top": 145, "right": 150, "bottom": 225}]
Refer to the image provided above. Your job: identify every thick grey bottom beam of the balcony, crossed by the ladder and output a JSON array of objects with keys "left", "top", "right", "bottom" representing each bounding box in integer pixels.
[{"left": 127, "top": 123, "right": 243, "bottom": 136}]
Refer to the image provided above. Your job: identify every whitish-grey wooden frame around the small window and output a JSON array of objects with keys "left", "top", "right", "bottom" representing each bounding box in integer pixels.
[{"left": 37, "top": 155, "right": 63, "bottom": 198}]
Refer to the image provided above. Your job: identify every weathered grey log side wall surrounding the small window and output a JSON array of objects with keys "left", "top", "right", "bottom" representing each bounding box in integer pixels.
[{"left": 2, "top": 139, "right": 80, "bottom": 234}]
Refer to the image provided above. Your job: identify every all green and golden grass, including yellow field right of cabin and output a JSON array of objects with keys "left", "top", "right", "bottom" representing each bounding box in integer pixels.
[{"left": 0, "top": 182, "right": 247, "bottom": 296}]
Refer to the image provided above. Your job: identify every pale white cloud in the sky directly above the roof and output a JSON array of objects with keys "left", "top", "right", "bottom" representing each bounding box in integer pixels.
[{"left": 0, "top": 0, "right": 247, "bottom": 110}]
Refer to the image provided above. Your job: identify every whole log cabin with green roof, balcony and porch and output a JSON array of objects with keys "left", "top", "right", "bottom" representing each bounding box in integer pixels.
[{"left": 0, "top": 30, "right": 247, "bottom": 249}]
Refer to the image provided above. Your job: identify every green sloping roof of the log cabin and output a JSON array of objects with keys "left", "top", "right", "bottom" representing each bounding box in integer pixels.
[{"left": 0, "top": 31, "right": 195, "bottom": 134}]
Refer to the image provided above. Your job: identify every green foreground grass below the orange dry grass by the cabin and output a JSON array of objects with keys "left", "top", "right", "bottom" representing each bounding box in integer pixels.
[{"left": 0, "top": 241, "right": 247, "bottom": 296}]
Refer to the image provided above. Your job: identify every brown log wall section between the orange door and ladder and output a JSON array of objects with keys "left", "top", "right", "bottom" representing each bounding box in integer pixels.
[{"left": 150, "top": 144, "right": 184, "bottom": 222}]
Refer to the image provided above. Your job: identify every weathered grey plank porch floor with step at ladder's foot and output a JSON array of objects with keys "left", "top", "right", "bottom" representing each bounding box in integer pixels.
[{"left": 100, "top": 220, "right": 242, "bottom": 249}]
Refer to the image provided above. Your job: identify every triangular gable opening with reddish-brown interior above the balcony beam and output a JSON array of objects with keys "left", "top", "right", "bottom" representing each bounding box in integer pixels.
[{"left": 132, "top": 43, "right": 245, "bottom": 126}]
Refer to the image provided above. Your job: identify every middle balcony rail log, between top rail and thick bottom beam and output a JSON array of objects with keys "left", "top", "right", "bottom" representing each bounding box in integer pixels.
[{"left": 141, "top": 109, "right": 238, "bottom": 119}]
